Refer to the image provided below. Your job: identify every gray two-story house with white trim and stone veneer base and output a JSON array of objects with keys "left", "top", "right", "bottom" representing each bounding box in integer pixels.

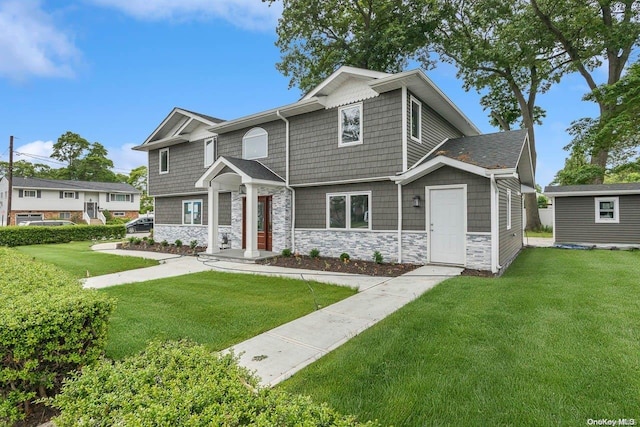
[{"left": 135, "top": 67, "right": 535, "bottom": 272}]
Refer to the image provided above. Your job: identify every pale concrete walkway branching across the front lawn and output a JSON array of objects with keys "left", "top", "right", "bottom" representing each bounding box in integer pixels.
[{"left": 84, "top": 243, "right": 462, "bottom": 386}]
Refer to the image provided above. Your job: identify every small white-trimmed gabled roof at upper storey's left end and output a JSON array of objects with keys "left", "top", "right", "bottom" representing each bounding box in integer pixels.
[{"left": 133, "top": 107, "right": 222, "bottom": 151}]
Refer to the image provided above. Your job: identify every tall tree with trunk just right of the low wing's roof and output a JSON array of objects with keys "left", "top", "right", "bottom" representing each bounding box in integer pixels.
[{"left": 423, "top": 0, "right": 565, "bottom": 229}]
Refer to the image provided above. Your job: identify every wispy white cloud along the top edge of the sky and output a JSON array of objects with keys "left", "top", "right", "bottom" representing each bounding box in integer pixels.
[{"left": 89, "top": 0, "right": 282, "bottom": 30}]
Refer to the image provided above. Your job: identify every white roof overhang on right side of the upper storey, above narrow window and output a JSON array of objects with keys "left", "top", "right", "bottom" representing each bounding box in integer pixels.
[{"left": 369, "top": 70, "right": 481, "bottom": 136}]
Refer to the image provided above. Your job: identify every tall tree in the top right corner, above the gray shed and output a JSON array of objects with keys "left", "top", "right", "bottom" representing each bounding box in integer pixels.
[{"left": 528, "top": 0, "right": 640, "bottom": 183}]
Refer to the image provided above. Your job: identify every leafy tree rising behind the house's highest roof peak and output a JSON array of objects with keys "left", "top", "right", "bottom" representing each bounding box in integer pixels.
[{"left": 263, "top": 0, "right": 428, "bottom": 92}]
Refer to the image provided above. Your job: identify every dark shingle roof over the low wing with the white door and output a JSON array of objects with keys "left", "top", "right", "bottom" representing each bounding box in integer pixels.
[{"left": 421, "top": 129, "right": 527, "bottom": 169}]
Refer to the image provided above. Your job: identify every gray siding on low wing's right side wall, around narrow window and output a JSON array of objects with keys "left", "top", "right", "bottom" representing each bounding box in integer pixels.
[{"left": 498, "top": 178, "right": 522, "bottom": 265}]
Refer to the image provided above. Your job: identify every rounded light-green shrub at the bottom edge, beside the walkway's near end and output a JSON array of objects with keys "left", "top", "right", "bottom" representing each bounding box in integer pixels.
[{"left": 50, "top": 341, "right": 374, "bottom": 427}]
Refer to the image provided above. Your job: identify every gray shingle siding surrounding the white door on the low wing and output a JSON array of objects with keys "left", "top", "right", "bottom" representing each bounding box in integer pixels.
[{"left": 402, "top": 166, "right": 491, "bottom": 233}]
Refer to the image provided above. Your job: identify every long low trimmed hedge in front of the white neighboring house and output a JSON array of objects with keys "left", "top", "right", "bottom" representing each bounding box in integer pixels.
[{"left": 0, "top": 225, "right": 126, "bottom": 246}]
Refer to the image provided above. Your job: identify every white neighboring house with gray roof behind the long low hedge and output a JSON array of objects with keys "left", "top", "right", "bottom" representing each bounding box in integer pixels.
[{"left": 0, "top": 177, "right": 141, "bottom": 226}]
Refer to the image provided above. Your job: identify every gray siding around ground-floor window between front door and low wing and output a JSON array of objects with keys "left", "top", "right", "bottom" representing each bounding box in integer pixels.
[{"left": 296, "top": 181, "right": 398, "bottom": 230}]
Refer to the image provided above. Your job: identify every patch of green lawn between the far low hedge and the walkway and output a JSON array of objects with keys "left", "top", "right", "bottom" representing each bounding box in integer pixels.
[{"left": 15, "top": 242, "right": 158, "bottom": 279}]
